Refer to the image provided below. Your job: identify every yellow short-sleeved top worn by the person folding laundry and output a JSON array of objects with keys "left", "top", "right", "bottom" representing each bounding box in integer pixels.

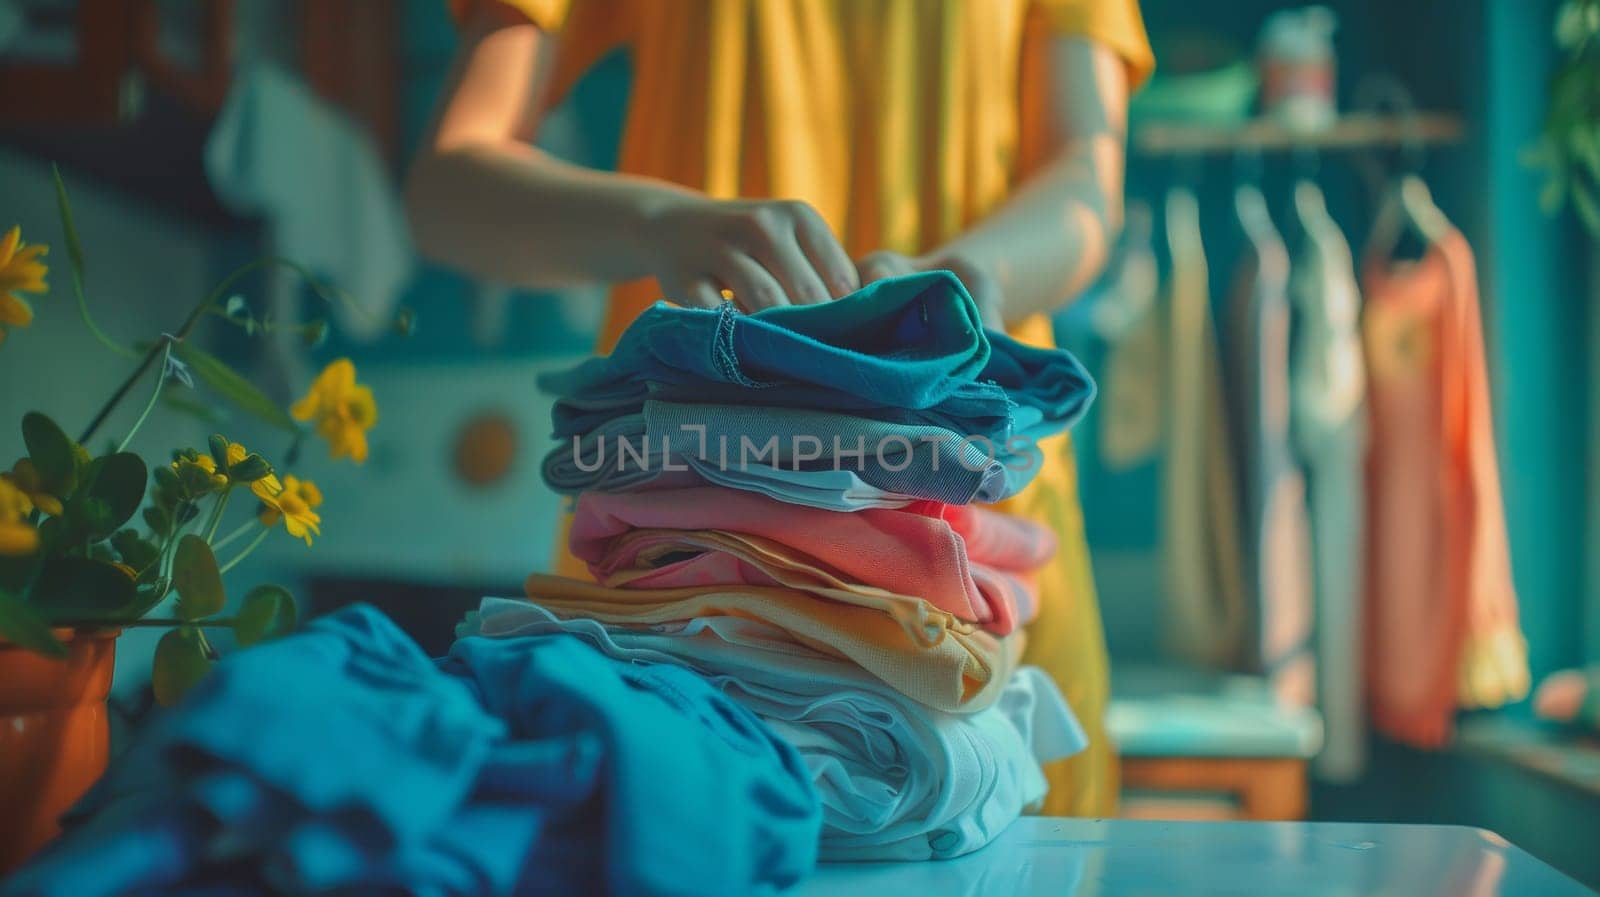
[{"left": 451, "top": 0, "right": 1154, "bottom": 815}]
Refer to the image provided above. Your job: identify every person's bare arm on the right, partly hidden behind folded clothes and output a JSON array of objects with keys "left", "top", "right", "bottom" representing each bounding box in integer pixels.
[{"left": 858, "top": 37, "right": 1128, "bottom": 326}]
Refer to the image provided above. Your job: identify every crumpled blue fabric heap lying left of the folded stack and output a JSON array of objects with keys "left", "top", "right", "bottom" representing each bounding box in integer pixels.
[{"left": 0, "top": 608, "right": 818, "bottom": 897}]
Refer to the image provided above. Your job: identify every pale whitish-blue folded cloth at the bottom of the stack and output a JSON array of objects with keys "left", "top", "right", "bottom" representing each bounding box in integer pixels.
[{"left": 461, "top": 598, "right": 1088, "bottom": 860}]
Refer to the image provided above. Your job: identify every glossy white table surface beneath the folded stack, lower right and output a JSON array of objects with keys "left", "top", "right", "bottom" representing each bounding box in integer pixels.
[{"left": 787, "top": 817, "right": 1595, "bottom": 897}]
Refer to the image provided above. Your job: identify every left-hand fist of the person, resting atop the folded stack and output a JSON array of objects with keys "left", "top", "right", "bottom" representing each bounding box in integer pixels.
[{"left": 646, "top": 197, "right": 861, "bottom": 312}]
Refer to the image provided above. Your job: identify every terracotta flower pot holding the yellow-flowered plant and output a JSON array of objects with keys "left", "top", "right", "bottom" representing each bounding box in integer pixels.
[{"left": 0, "top": 630, "right": 122, "bottom": 876}]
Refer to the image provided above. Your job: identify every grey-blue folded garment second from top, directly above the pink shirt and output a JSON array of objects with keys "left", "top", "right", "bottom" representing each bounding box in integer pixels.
[{"left": 544, "top": 400, "right": 1043, "bottom": 508}]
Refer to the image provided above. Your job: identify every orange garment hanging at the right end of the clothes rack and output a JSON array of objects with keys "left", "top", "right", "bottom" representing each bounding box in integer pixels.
[{"left": 1362, "top": 229, "right": 1528, "bottom": 747}]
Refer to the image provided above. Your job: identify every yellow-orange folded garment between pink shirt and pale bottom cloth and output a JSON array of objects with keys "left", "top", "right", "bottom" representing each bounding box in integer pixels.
[{"left": 525, "top": 574, "right": 1022, "bottom": 713}]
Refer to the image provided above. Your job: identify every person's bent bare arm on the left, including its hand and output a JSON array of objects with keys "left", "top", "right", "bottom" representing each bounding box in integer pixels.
[{"left": 406, "top": 10, "right": 859, "bottom": 309}]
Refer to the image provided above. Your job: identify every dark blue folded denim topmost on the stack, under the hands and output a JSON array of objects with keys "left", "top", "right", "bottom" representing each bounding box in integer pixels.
[{"left": 539, "top": 272, "right": 1094, "bottom": 440}]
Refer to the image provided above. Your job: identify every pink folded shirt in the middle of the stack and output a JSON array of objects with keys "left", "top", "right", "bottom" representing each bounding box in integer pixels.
[{"left": 570, "top": 488, "right": 1054, "bottom": 635}]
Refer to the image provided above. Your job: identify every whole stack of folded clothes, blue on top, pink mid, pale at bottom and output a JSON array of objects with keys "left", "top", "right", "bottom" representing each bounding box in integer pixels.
[{"left": 462, "top": 272, "right": 1094, "bottom": 860}]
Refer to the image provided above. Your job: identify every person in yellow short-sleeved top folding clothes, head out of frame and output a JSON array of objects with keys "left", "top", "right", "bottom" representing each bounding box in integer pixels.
[{"left": 406, "top": 0, "right": 1154, "bottom": 815}]
